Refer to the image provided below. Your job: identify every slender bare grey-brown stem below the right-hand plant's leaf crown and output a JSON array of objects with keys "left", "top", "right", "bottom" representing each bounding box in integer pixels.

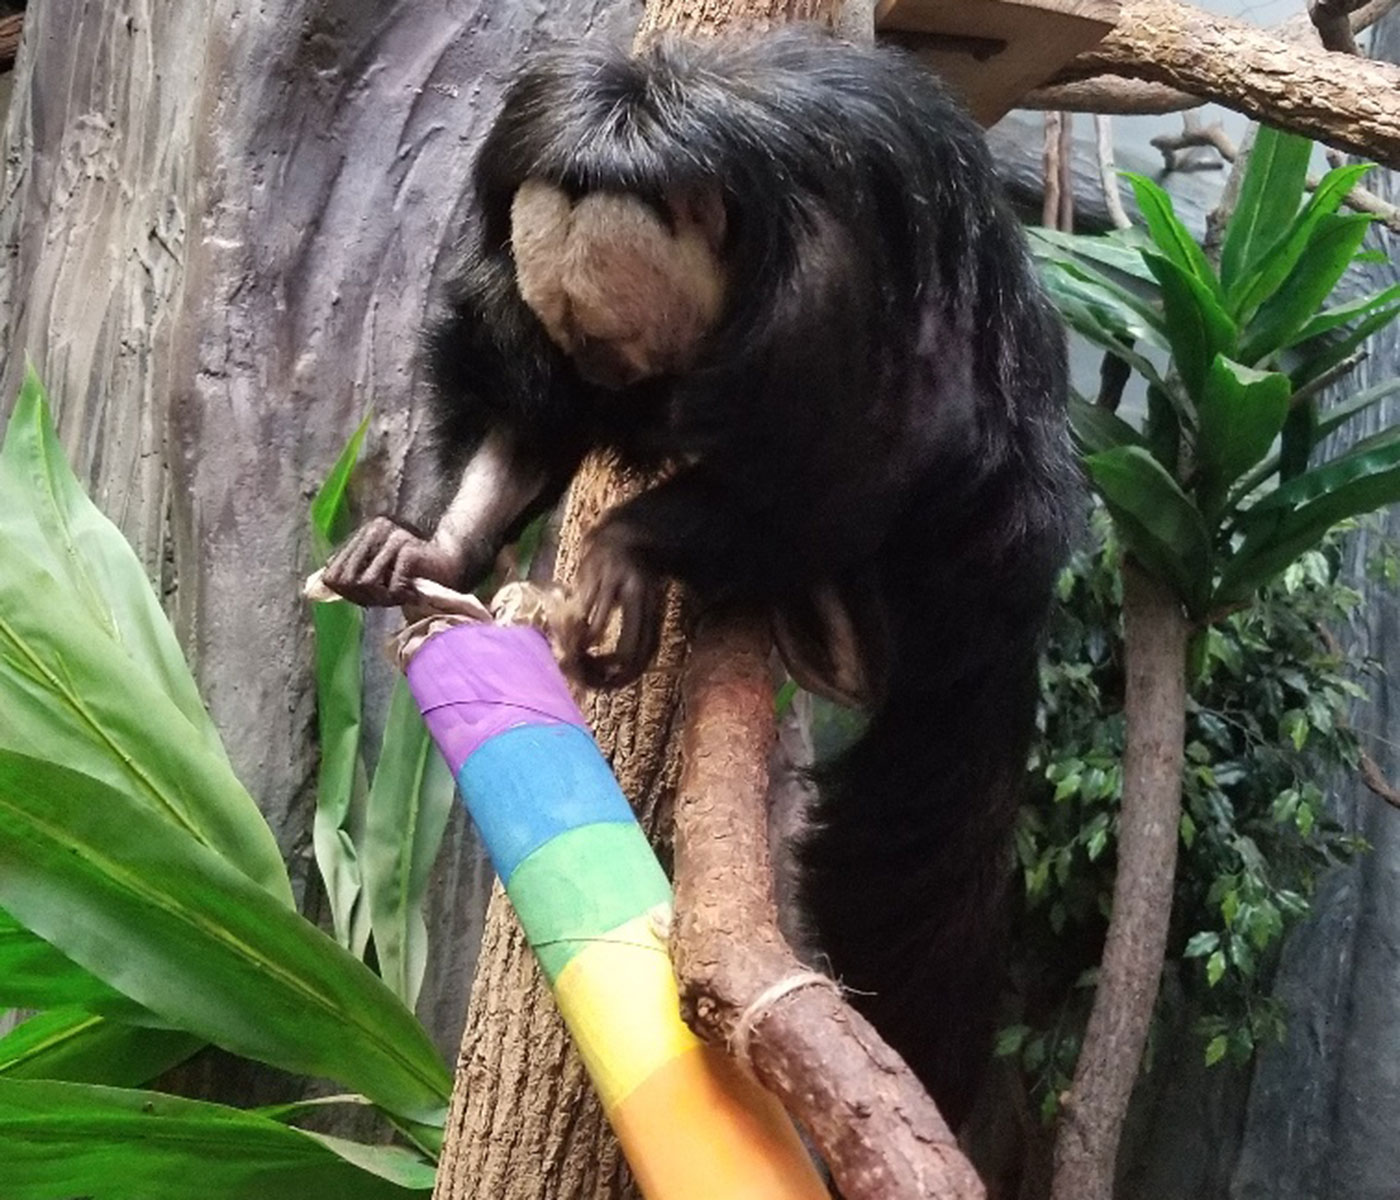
[{"left": 1051, "top": 560, "right": 1190, "bottom": 1200}]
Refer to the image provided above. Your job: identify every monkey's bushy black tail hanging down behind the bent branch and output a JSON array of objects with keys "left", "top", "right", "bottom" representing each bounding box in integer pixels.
[{"left": 801, "top": 625, "right": 1036, "bottom": 1130}]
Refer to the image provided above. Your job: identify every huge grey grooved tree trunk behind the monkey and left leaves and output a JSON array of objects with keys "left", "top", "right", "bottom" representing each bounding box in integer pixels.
[{"left": 0, "top": 0, "right": 637, "bottom": 1102}]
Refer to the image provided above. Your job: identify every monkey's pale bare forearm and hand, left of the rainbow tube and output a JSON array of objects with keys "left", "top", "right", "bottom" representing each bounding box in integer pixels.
[{"left": 323, "top": 431, "right": 549, "bottom": 606}]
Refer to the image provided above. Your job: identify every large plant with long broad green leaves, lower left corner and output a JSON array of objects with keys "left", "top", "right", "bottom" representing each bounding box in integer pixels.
[{"left": 0, "top": 371, "right": 449, "bottom": 1200}]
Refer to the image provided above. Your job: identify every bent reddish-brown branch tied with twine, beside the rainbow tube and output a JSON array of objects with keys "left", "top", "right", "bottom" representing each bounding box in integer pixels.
[{"left": 672, "top": 619, "right": 986, "bottom": 1200}]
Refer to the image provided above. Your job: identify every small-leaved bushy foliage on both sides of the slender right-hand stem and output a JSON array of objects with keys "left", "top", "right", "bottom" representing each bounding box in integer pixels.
[{"left": 1000, "top": 508, "right": 1365, "bottom": 1117}]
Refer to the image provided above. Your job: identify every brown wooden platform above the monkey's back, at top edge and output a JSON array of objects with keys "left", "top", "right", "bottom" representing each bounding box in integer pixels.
[{"left": 875, "top": 0, "right": 1119, "bottom": 125}]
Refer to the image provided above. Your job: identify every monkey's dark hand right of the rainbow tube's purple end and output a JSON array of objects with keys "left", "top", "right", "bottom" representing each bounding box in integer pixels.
[{"left": 560, "top": 521, "right": 664, "bottom": 688}]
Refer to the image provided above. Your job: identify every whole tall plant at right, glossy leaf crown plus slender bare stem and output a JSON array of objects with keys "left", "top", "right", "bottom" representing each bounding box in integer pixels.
[{"left": 1036, "top": 129, "right": 1400, "bottom": 1200}]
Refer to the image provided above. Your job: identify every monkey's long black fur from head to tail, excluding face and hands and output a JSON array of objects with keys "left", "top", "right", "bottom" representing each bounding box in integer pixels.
[{"left": 431, "top": 32, "right": 1075, "bottom": 1123}]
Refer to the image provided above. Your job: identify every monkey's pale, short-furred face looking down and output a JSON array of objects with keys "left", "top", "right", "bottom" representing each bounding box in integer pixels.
[{"left": 511, "top": 179, "right": 724, "bottom": 388}]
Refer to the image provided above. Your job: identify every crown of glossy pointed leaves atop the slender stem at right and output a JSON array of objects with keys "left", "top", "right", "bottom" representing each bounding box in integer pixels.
[{"left": 1033, "top": 127, "right": 1400, "bottom": 622}]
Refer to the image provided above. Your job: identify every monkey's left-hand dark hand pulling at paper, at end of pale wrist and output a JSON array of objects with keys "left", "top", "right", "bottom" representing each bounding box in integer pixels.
[{"left": 322, "top": 517, "right": 493, "bottom": 608}]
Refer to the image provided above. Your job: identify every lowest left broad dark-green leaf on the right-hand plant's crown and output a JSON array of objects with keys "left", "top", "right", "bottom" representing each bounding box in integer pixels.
[{"left": 1084, "top": 445, "right": 1211, "bottom": 612}]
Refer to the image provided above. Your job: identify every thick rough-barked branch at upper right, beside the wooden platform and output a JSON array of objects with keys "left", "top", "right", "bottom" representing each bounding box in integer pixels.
[{"left": 1037, "top": 0, "right": 1400, "bottom": 167}]
